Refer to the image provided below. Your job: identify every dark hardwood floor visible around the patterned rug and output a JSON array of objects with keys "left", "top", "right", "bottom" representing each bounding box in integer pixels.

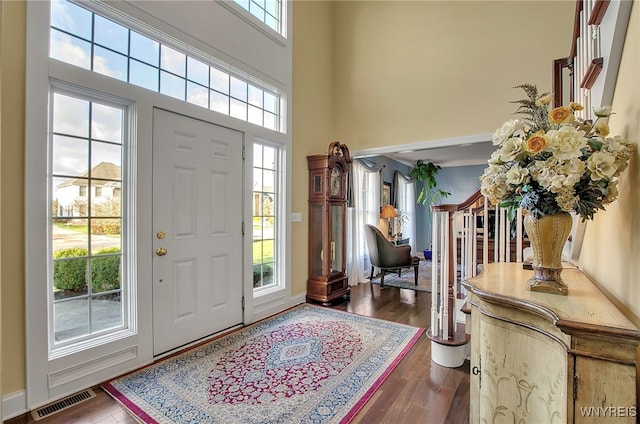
[{"left": 6, "top": 283, "right": 469, "bottom": 424}]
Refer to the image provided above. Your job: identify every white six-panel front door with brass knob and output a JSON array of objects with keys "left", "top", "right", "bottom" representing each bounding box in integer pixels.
[{"left": 152, "top": 109, "right": 243, "bottom": 355}]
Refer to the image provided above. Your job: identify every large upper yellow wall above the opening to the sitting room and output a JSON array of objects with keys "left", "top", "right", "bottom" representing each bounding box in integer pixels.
[{"left": 334, "top": 1, "right": 575, "bottom": 151}]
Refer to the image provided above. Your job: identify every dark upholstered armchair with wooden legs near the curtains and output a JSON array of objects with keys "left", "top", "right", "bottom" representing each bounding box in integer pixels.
[{"left": 365, "top": 224, "right": 420, "bottom": 288}]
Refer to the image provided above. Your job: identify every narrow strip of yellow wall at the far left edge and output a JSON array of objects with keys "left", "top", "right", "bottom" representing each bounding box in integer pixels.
[{"left": 0, "top": 1, "right": 26, "bottom": 394}]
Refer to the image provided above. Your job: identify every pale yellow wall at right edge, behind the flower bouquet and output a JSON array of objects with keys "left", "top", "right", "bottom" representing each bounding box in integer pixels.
[{"left": 580, "top": 1, "right": 640, "bottom": 325}]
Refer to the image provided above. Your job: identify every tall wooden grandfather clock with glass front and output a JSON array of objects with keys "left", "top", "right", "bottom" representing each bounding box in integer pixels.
[{"left": 307, "top": 141, "right": 351, "bottom": 305}]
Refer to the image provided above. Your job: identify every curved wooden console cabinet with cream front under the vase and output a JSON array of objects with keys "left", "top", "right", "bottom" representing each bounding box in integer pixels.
[{"left": 463, "top": 263, "right": 640, "bottom": 424}]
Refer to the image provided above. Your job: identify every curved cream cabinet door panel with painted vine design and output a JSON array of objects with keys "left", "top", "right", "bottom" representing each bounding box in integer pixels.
[{"left": 474, "top": 315, "right": 568, "bottom": 423}]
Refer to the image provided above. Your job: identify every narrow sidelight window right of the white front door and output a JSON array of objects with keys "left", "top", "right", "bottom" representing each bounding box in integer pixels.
[{"left": 253, "top": 143, "right": 278, "bottom": 288}]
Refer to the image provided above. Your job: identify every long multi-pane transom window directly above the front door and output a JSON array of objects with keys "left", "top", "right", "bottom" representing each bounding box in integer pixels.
[{"left": 49, "top": 0, "right": 280, "bottom": 131}]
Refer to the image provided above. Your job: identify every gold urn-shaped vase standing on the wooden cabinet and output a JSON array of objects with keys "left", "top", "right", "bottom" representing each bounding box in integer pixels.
[{"left": 524, "top": 212, "right": 573, "bottom": 295}]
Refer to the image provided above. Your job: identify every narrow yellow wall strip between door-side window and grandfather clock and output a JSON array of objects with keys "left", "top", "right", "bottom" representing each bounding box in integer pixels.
[{"left": 291, "top": 1, "right": 338, "bottom": 295}]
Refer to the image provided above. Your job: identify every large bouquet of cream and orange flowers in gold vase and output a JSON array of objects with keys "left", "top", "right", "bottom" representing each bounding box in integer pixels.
[{"left": 480, "top": 84, "right": 635, "bottom": 220}]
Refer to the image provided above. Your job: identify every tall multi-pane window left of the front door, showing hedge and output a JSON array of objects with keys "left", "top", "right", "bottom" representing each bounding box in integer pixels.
[{"left": 49, "top": 90, "right": 127, "bottom": 350}]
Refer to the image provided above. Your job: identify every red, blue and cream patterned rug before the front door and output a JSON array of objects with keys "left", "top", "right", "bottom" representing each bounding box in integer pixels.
[{"left": 102, "top": 304, "right": 423, "bottom": 424}]
